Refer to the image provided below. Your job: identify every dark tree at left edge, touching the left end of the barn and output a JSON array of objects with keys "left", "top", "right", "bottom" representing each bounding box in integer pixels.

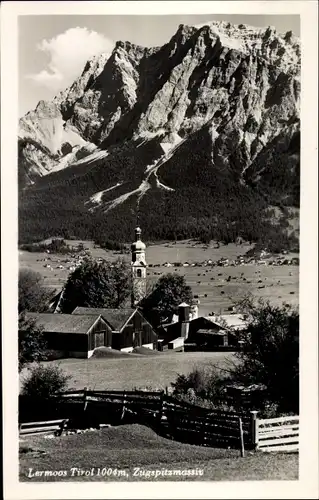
[{"left": 19, "top": 314, "right": 47, "bottom": 371}]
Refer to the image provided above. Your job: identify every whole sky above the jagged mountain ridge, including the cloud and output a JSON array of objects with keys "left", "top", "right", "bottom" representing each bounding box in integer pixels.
[{"left": 18, "top": 14, "right": 300, "bottom": 116}]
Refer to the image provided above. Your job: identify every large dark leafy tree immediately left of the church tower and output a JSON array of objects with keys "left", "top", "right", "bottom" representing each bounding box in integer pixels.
[{"left": 61, "top": 259, "right": 131, "bottom": 313}]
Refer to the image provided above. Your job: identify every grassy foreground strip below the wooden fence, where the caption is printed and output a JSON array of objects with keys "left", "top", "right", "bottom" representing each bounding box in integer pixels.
[{"left": 20, "top": 425, "right": 298, "bottom": 482}]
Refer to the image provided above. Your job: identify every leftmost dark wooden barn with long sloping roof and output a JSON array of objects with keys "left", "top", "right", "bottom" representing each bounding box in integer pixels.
[{"left": 19, "top": 312, "right": 112, "bottom": 359}]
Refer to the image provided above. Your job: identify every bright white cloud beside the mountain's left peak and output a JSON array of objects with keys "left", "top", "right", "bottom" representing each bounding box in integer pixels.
[{"left": 27, "top": 27, "right": 114, "bottom": 91}]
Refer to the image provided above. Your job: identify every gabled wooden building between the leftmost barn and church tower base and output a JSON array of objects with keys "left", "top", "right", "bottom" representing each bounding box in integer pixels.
[{"left": 72, "top": 307, "right": 157, "bottom": 352}]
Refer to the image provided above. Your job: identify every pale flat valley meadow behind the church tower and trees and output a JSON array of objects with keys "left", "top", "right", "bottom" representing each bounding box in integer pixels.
[{"left": 19, "top": 241, "right": 299, "bottom": 315}]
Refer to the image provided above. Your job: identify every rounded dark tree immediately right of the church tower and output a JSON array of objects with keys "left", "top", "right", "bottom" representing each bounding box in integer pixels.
[{"left": 140, "top": 273, "right": 193, "bottom": 324}]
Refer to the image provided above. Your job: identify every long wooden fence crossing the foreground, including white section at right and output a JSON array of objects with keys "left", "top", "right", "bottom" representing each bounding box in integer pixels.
[{"left": 19, "top": 390, "right": 299, "bottom": 451}]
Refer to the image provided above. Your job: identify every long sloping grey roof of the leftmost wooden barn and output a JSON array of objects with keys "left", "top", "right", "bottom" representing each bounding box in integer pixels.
[{"left": 26, "top": 313, "right": 99, "bottom": 333}]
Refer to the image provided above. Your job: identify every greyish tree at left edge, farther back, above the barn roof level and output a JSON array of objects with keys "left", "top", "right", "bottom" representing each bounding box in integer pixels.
[{"left": 18, "top": 269, "right": 55, "bottom": 312}]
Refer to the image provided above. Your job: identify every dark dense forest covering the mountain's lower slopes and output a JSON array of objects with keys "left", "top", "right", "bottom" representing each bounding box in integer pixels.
[{"left": 19, "top": 124, "right": 300, "bottom": 251}]
